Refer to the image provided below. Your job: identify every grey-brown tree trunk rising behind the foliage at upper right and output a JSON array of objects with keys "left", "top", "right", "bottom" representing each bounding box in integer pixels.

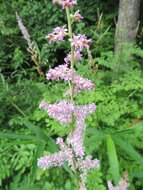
[{"left": 115, "top": 0, "right": 140, "bottom": 55}]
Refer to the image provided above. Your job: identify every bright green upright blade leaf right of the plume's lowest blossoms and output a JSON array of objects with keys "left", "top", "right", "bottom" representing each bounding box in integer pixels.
[{"left": 106, "top": 135, "right": 120, "bottom": 184}]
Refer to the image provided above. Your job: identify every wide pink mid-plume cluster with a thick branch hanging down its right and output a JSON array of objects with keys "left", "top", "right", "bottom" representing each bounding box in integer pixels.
[{"left": 39, "top": 100, "right": 96, "bottom": 157}]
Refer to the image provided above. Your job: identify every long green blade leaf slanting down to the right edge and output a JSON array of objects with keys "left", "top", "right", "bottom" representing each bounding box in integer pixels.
[{"left": 114, "top": 137, "right": 143, "bottom": 164}]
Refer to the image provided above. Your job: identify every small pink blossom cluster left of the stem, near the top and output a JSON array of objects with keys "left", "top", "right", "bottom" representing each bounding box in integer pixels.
[{"left": 46, "top": 26, "right": 67, "bottom": 43}]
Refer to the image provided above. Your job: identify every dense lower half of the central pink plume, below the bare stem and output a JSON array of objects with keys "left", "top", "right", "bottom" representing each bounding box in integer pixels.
[{"left": 38, "top": 101, "right": 100, "bottom": 190}]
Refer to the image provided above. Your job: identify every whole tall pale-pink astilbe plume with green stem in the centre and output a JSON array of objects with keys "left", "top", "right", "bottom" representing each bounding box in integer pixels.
[{"left": 38, "top": 0, "right": 99, "bottom": 190}]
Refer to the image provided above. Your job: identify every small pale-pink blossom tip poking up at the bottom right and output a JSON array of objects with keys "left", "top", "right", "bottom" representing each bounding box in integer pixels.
[{"left": 108, "top": 173, "right": 129, "bottom": 190}]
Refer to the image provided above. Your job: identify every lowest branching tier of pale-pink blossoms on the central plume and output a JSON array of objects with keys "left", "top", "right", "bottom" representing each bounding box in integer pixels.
[{"left": 38, "top": 138, "right": 100, "bottom": 187}]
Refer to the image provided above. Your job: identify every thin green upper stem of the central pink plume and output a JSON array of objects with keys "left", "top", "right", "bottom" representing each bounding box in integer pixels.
[{"left": 66, "top": 7, "right": 74, "bottom": 102}]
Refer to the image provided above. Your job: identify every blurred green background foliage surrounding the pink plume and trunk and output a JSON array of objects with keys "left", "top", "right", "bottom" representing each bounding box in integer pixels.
[{"left": 0, "top": 0, "right": 143, "bottom": 190}]
